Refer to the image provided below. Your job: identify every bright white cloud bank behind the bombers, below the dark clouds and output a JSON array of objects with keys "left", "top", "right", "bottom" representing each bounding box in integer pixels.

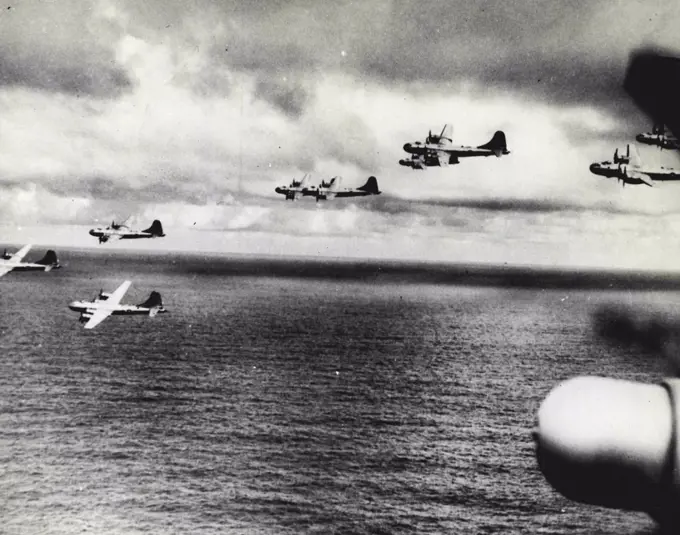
[{"left": 0, "top": 3, "right": 680, "bottom": 268}]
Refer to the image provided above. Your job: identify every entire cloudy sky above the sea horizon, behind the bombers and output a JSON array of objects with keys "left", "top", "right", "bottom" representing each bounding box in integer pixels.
[{"left": 0, "top": 0, "right": 680, "bottom": 270}]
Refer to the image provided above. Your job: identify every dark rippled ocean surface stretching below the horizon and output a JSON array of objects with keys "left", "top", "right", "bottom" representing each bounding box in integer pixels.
[{"left": 0, "top": 250, "right": 680, "bottom": 534}]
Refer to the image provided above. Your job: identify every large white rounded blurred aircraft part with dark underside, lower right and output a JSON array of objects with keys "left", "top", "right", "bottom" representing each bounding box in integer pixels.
[{"left": 534, "top": 377, "right": 680, "bottom": 530}]
